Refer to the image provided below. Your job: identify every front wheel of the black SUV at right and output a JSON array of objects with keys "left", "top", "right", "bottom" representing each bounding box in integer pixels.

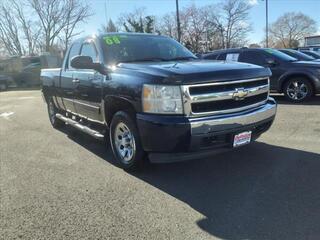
[{"left": 283, "top": 77, "right": 313, "bottom": 103}]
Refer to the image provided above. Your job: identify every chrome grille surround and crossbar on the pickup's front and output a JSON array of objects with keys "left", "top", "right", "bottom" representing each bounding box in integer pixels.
[{"left": 181, "top": 77, "right": 270, "bottom": 117}]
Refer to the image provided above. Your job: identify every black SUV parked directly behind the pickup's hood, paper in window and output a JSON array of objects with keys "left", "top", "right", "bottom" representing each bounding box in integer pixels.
[{"left": 202, "top": 48, "right": 320, "bottom": 102}]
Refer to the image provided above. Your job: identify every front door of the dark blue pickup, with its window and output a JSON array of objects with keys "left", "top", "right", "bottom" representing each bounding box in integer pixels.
[{"left": 73, "top": 40, "right": 104, "bottom": 122}]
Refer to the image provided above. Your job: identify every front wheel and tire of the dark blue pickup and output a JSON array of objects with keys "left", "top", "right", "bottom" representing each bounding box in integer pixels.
[{"left": 109, "top": 111, "right": 145, "bottom": 171}]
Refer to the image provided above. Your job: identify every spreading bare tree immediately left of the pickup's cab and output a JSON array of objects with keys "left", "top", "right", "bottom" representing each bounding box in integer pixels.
[{"left": 29, "top": 0, "right": 90, "bottom": 52}]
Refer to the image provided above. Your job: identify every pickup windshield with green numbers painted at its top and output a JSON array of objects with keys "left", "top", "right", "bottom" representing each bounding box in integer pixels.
[{"left": 101, "top": 34, "right": 196, "bottom": 64}]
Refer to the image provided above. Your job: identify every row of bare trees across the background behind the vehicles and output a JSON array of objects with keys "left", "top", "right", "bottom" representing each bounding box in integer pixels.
[{"left": 0, "top": 0, "right": 317, "bottom": 56}]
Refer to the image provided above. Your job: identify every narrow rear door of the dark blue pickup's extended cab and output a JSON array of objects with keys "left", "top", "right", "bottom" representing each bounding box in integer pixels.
[{"left": 59, "top": 42, "right": 81, "bottom": 113}]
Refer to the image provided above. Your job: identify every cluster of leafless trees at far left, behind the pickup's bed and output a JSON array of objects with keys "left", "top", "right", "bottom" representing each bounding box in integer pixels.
[{"left": 0, "top": 0, "right": 92, "bottom": 56}]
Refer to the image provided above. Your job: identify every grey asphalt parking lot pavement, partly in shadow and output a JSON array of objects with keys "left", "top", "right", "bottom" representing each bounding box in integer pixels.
[{"left": 0, "top": 91, "right": 320, "bottom": 240}]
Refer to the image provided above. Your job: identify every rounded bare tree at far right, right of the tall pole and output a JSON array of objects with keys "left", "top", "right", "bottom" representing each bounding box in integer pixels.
[{"left": 269, "top": 12, "right": 317, "bottom": 48}]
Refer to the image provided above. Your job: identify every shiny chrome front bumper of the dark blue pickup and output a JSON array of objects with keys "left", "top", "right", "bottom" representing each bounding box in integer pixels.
[{"left": 189, "top": 98, "right": 277, "bottom": 135}]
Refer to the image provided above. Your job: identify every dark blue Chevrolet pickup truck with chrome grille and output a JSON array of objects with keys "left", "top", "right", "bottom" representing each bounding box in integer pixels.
[{"left": 41, "top": 33, "right": 276, "bottom": 169}]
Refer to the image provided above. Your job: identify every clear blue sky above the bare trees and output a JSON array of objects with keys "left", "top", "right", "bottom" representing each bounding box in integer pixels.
[{"left": 79, "top": 0, "right": 320, "bottom": 43}]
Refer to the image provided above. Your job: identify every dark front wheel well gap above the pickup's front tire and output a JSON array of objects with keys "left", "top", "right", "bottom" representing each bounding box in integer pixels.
[{"left": 104, "top": 97, "right": 136, "bottom": 126}]
